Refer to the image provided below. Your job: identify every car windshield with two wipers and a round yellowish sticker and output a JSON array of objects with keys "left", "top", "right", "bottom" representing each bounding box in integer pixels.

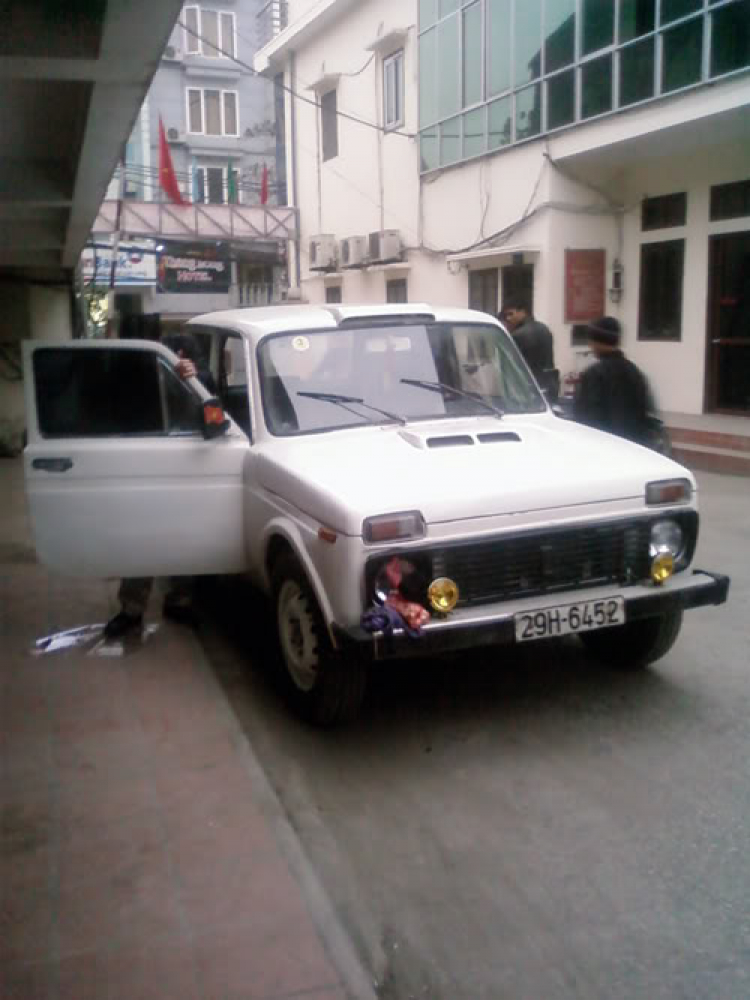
[{"left": 258, "top": 323, "right": 546, "bottom": 435}]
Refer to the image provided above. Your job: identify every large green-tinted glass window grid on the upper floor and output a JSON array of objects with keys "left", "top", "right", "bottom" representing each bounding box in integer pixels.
[{"left": 419, "top": 0, "right": 750, "bottom": 172}]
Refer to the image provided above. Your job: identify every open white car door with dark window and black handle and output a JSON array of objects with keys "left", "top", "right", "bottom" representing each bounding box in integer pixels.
[{"left": 24, "top": 340, "right": 250, "bottom": 577}]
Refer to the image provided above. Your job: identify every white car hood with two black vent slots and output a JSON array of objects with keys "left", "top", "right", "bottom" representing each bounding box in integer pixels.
[{"left": 255, "top": 414, "right": 692, "bottom": 535}]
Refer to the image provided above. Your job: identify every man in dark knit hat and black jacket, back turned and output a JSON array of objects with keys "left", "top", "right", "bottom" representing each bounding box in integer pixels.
[{"left": 573, "top": 316, "right": 651, "bottom": 444}]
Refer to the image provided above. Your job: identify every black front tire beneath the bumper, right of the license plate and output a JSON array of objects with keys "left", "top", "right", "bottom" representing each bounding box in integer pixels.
[{"left": 580, "top": 608, "right": 682, "bottom": 670}]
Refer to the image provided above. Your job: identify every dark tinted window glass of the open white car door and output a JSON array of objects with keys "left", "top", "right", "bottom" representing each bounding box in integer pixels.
[{"left": 34, "top": 348, "right": 200, "bottom": 438}]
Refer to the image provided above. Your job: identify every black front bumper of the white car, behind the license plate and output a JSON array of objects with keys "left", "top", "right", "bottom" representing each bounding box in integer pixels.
[{"left": 331, "top": 570, "right": 729, "bottom": 661}]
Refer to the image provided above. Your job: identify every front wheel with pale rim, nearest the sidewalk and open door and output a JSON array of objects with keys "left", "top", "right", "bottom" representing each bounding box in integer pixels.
[{"left": 271, "top": 552, "right": 367, "bottom": 728}]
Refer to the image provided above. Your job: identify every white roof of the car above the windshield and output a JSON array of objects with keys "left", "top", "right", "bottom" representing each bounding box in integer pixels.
[{"left": 188, "top": 302, "right": 506, "bottom": 342}]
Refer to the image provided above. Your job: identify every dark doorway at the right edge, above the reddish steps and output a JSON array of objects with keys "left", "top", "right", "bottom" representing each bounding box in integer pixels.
[{"left": 706, "top": 232, "right": 750, "bottom": 416}]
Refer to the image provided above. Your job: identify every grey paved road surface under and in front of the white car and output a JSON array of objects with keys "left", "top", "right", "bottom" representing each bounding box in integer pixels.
[{"left": 198, "top": 475, "right": 750, "bottom": 1000}]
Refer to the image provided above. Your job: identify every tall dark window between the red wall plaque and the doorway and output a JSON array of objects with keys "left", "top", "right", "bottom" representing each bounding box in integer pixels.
[{"left": 638, "top": 240, "right": 685, "bottom": 340}]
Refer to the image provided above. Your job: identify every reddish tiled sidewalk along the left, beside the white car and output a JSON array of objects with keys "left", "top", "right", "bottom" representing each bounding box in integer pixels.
[{"left": 0, "top": 459, "right": 374, "bottom": 1000}]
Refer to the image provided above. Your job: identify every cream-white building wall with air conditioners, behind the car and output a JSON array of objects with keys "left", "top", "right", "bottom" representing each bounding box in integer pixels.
[{"left": 287, "top": 0, "right": 750, "bottom": 413}]
